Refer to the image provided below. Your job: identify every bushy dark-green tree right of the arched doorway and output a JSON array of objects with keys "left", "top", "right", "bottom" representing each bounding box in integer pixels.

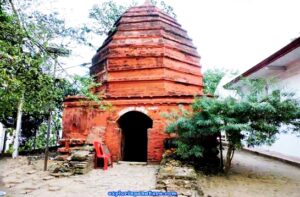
[{"left": 166, "top": 81, "right": 300, "bottom": 173}]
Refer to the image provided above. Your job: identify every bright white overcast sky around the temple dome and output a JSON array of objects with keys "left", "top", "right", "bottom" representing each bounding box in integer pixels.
[{"left": 40, "top": 0, "right": 300, "bottom": 74}]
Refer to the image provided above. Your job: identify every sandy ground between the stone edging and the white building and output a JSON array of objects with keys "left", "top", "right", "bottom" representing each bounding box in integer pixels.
[{"left": 198, "top": 151, "right": 300, "bottom": 197}]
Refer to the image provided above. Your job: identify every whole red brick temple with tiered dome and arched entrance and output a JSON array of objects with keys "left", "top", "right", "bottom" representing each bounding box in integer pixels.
[{"left": 63, "top": 4, "right": 203, "bottom": 162}]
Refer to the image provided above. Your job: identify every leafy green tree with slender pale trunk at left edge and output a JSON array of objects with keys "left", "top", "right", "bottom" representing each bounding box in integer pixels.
[{"left": 0, "top": 3, "right": 63, "bottom": 157}]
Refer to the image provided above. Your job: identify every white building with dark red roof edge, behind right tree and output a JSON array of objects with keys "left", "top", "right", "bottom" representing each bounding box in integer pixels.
[{"left": 225, "top": 37, "right": 300, "bottom": 158}]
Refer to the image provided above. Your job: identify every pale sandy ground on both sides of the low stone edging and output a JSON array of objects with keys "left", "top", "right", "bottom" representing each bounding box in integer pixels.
[{"left": 0, "top": 152, "right": 300, "bottom": 197}]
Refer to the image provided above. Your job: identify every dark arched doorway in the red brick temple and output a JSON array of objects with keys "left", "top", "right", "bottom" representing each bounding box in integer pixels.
[{"left": 118, "top": 111, "right": 153, "bottom": 162}]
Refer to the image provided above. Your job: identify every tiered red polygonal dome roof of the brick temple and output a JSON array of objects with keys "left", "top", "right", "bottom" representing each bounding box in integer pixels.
[{"left": 90, "top": 3, "right": 203, "bottom": 99}]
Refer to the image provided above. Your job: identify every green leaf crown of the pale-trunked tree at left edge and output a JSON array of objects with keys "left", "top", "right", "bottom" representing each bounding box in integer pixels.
[{"left": 0, "top": 5, "right": 51, "bottom": 121}]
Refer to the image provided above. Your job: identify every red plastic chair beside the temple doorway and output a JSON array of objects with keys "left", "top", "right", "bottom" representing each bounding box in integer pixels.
[{"left": 94, "top": 141, "right": 113, "bottom": 170}]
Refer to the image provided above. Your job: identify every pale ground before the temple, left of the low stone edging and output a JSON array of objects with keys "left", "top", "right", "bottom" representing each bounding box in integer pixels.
[{"left": 0, "top": 157, "right": 158, "bottom": 197}]
